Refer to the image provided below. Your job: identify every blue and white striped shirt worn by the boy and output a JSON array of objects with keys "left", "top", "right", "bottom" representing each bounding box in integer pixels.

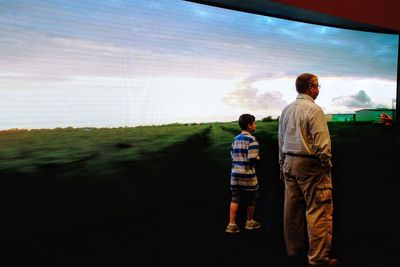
[{"left": 231, "top": 131, "right": 258, "bottom": 190}]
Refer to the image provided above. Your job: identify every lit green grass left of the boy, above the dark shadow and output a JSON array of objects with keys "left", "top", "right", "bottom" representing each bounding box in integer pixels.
[{"left": 0, "top": 124, "right": 209, "bottom": 176}]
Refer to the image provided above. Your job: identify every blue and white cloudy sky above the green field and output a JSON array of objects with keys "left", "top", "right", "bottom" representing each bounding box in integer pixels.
[{"left": 0, "top": 0, "right": 399, "bottom": 130}]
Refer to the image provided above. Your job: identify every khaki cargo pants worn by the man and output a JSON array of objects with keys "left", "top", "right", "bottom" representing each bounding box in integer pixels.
[{"left": 282, "top": 155, "right": 333, "bottom": 264}]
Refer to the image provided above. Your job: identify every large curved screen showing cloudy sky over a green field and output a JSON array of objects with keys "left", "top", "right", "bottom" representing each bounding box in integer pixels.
[{"left": 0, "top": 0, "right": 400, "bottom": 267}]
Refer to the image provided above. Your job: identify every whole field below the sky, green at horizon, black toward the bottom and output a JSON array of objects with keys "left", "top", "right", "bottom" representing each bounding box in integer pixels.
[{"left": 0, "top": 122, "right": 400, "bottom": 266}]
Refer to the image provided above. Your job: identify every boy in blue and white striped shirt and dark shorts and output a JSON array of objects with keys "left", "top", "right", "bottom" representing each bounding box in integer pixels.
[{"left": 225, "top": 114, "right": 261, "bottom": 233}]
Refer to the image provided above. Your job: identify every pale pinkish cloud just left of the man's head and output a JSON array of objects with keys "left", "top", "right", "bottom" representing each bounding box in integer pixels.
[{"left": 223, "top": 75, "right": 287, "bottom": 110}]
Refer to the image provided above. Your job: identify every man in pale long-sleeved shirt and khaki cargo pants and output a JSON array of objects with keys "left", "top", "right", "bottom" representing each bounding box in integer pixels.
[{"left": 279, "top": 73, "right": 337, "bottom": 267}]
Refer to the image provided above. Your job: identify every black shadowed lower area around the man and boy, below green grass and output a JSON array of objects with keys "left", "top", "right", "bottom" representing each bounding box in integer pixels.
[{"left": 0, "top": 126, "right": 400, "bottom": 267}]
